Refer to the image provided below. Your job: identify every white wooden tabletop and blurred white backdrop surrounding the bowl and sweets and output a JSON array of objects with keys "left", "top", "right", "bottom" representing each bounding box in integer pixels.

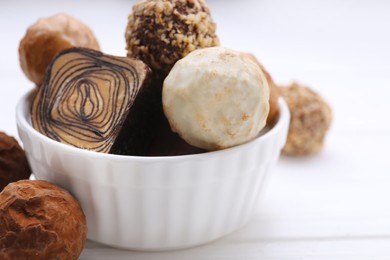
[{"left": 0, "top": 0, "right": 390, "bottom": 260}]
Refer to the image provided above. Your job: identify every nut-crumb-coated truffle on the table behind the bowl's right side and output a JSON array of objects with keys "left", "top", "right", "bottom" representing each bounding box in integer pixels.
[{"left": 280, "top": 83, "right": 332, "bottom": 155}]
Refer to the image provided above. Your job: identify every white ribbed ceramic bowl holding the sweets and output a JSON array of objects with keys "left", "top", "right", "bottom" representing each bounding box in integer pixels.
[{"left": 16, "top": 90, "right": 290, "bottom": 250}]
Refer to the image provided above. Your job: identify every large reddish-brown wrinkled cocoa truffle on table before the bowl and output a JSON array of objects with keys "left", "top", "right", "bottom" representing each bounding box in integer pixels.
[{"left": 0, "top": 180, "right": 87, "bottom": 260}]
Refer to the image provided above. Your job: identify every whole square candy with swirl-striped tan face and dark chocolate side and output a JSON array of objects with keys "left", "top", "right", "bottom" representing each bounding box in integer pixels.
[{"left": 32, "top": 48, "right": 161, "bottom": 155}]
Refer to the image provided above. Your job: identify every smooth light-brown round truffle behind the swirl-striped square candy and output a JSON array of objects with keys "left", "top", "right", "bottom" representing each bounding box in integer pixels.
[{"left": 19, "top": 13, "right": 99, "bottom": 86}]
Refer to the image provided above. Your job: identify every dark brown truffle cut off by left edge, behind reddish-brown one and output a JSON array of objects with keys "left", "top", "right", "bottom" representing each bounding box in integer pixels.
[{"left": 0, "top": 132, "right": 31, "bottom": 191}]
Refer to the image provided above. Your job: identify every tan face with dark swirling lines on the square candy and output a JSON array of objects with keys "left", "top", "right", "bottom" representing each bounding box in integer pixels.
[{"left": 32, "top": 48, "right": 148, "bottom": 153}]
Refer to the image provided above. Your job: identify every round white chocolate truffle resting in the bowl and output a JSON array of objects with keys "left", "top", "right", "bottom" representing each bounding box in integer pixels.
[{"left": 162, "top": 47, "right": 269, "bottom": 150}]
